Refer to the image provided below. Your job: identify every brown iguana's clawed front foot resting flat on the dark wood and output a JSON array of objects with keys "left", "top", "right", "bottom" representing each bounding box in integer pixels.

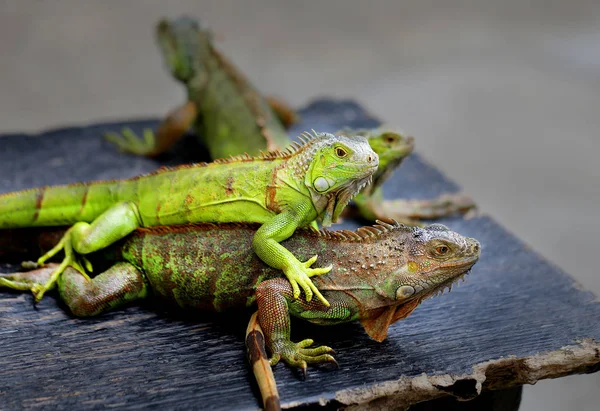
[{"left": 269, "top": 339, "right": 338, "bottom": 377}]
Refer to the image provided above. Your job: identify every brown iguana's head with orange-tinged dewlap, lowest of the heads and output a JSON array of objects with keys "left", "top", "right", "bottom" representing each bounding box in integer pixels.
[{"left": 361, "top": 222, "right": 480, "bottom": 341}]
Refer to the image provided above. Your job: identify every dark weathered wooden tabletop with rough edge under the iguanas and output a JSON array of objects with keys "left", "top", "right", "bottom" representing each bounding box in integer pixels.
[{"left": 0, "top": 100, "right": 600, "bottom": 409}]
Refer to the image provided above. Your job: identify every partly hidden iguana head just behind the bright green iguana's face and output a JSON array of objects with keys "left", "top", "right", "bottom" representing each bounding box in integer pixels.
[{"left": 336, "top": 127, "right": 415, "bottom": 191}]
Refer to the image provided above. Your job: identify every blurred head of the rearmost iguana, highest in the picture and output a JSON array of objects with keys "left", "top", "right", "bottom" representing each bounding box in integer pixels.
[{"left": 156, "top": 17, "right": 212, "bottom": 83}]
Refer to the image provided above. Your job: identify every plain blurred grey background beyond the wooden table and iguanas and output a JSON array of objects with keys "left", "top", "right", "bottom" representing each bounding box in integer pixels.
[{"left": 0, "top": 0, "right": 600, "bottom": 411}]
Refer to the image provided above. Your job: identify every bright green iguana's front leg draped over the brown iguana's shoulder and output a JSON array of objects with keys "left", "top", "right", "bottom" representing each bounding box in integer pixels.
[{"left": 252, "top": 209, "right": 333, "bottom": 306}]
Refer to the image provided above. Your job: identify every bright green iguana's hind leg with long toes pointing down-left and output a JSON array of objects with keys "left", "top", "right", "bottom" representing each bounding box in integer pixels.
[{"left": 32, "top": 202, "right": 142, "bottom": 301}]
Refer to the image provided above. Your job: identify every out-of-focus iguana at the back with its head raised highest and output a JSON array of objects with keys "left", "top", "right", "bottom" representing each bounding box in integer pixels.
[{"left": 106, "top": 18, "right": 291, "bottom": 159}]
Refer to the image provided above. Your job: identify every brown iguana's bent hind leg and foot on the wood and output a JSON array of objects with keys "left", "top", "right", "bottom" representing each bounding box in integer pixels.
[{"left": 0, "top": 262, "right": 148, "bottom": 317}]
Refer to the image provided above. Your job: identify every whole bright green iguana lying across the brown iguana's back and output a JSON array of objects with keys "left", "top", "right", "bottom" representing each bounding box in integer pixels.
[{"left": 0, "top": 133, "right": 378, "bottom": 303}]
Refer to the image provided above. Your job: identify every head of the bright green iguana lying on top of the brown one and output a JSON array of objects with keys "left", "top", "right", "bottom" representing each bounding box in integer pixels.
[{"left": 297, "top": 131, "right": 379, "bottom": 227}]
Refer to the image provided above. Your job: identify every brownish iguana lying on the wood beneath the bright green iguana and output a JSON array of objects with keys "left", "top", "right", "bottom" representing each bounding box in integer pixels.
[{"left": 0, "top": 222, "right": 480, "bottom": 410}]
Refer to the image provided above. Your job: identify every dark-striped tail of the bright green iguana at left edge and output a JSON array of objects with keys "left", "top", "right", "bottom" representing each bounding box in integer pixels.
[{"left": 0, "top": 181, "right": 129, "bottom": 229}]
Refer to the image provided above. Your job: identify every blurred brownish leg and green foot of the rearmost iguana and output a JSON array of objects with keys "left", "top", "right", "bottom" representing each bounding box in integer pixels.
[{"left": 105, "top": 101, "right": 198, "bottom": 157}]
